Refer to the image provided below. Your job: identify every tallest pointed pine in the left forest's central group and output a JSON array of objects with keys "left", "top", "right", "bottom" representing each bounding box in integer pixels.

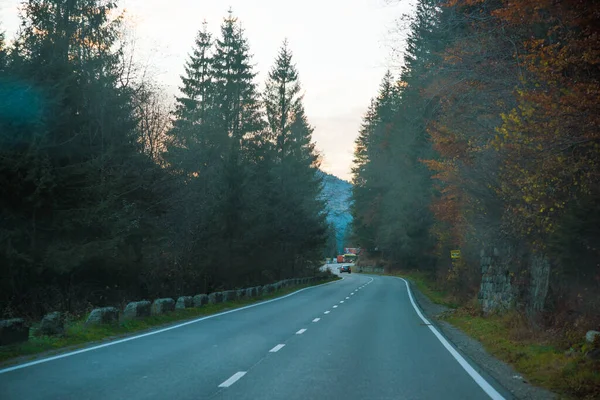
[{"left": 202, "top": 11, "right": 264, "bottom": 277}]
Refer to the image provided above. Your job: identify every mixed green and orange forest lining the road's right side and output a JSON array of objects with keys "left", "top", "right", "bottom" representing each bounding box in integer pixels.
[{"left": 352, "top": 0, "right": 600, "bottom": 338}]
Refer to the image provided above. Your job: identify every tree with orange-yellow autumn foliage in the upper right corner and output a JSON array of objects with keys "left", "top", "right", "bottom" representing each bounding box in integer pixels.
[{"left": 494, "top": 0, "right": 600, "bottom": 242}]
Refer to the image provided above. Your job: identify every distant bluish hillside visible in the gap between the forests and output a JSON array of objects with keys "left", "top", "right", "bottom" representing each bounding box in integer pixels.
[{"left": 322, "top": 172, "right": 352, "bottom": 253}]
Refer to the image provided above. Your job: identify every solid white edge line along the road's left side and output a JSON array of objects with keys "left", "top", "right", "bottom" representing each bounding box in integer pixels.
[{"left": 0, "top": 277, "right": 345, "bottom": 374}]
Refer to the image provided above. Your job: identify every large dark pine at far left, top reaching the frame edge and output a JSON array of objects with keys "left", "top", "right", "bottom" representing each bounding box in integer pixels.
[{"left": 0, "top": 0, "right": 162, "bottom": 309}]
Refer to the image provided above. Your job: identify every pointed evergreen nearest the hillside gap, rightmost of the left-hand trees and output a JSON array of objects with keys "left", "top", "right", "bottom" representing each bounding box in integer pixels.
[{"left": 264, "top": 41, "right": 327, "bottom": 276}]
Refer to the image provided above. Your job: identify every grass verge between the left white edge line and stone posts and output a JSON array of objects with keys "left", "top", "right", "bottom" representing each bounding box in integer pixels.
[{"left": 0, "top": 277, "right": 339, "bottom": 366}]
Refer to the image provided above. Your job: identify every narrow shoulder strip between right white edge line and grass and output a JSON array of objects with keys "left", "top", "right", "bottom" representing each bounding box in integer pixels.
[{"left": 406, "top": 279, "right": 558, "bottom": 400}]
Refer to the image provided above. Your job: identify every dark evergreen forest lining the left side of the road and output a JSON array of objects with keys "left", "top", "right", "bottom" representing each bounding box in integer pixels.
[{"left": 0, "top": 0, "right": 335, "bottom": 318}]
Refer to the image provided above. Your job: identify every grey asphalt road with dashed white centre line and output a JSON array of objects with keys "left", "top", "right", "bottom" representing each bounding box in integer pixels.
[{"left": 0, "top": 266, "right": 502, "bottom": 400}]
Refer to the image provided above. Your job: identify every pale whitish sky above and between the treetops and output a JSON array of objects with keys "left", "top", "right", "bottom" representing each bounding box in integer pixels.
[{"left": 0, "top": 0, "right": 411, "bottom": 180}]
